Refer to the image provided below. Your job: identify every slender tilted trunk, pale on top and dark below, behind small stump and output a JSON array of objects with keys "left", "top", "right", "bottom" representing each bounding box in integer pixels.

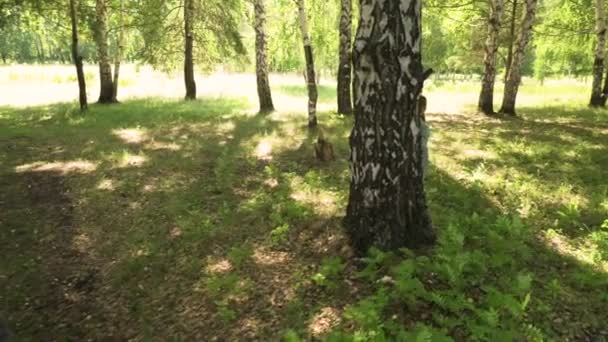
[{"left": 297, "top": 0, "right": 319, "bottom": 128}]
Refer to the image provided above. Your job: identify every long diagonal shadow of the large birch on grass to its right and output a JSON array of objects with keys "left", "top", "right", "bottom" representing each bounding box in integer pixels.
[{"left": 427, "top": 167, "right": 608, "bottom": 340}]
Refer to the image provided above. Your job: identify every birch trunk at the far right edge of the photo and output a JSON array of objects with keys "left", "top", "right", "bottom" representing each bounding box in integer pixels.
[{"left": 589, "top": 0, "right": 606, "bottom": 107}]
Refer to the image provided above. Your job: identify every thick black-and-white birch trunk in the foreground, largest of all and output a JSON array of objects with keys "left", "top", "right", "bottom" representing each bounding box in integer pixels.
[{"left": 344, "top": 0, "right": 435, "bottom": 253}]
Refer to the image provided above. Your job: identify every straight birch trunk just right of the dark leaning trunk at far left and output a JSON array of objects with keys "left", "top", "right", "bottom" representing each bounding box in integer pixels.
[{"left": 95, "top": 0, "right": 114, "bottom": 103}]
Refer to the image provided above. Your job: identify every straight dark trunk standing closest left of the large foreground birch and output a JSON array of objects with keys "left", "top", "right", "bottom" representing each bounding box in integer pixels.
[{"left": 338, "top": 0, "right": 353, "bottom": 114}]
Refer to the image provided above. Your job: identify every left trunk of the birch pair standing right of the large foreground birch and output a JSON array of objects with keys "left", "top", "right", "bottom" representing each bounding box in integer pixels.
[{"left": 478, "top": 0, "right": 504, "bottom": 115}]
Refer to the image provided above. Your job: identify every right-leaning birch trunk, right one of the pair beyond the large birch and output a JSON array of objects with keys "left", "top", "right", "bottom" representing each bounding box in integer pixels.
[{"left": 500, "top": 0, "right": 538, "bottom": 116}]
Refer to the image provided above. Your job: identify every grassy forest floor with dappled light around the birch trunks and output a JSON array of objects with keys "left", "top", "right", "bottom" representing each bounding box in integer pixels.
[{"left": 0, "top": 66, "right": 608, "bottom": 341}]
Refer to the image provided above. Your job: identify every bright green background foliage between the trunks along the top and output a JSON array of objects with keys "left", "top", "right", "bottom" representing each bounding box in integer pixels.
[{"left": 0, "top": 0, "right": 595, "bottom": 78}]
